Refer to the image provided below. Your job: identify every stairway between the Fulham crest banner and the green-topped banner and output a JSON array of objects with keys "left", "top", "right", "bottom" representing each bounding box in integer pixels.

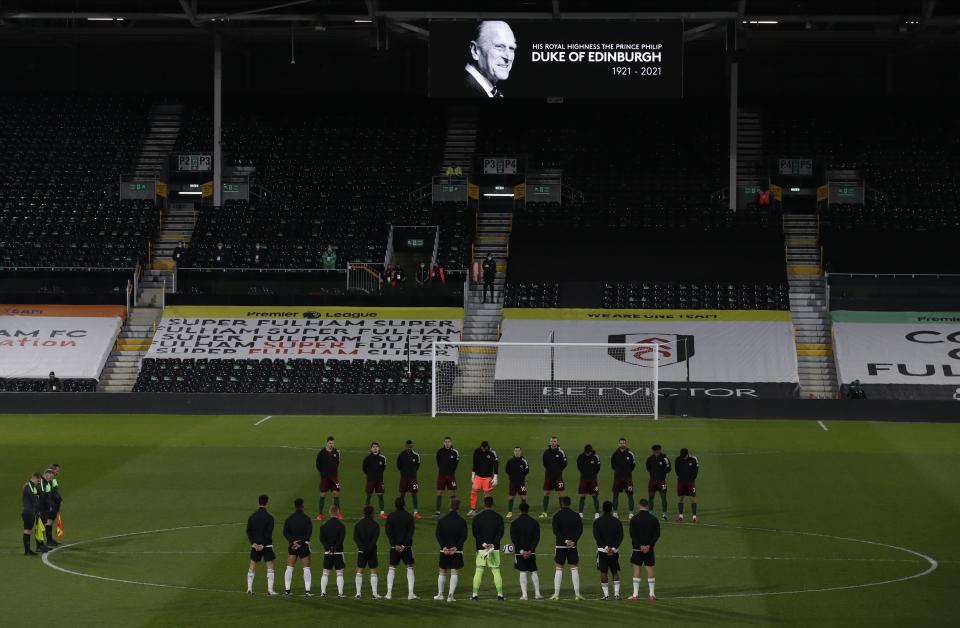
[{"left": 783, "top": 214, "right": 838, "bottom": 399}]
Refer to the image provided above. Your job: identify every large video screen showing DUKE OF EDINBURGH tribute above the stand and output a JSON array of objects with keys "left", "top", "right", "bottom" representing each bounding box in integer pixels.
[{"left": 430, "top": 19, "right": 683, "bottom": 99}]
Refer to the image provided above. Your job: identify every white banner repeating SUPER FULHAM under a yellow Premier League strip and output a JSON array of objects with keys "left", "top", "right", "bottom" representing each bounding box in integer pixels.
[{"left": 147, "top": 306, "right": 463, "bottom": 360}]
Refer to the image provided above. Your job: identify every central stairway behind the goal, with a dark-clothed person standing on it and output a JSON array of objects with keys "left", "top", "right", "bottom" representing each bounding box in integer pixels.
[{"left": 453, "top": 211, "right": 513, "bottom": 395}]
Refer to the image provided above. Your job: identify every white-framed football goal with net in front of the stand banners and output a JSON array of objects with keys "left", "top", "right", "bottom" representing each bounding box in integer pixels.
[{"left": 431, "top": 342, "right": 663, "bottom": 418}]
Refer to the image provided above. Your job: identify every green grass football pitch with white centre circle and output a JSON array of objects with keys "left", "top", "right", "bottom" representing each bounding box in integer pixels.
[{"left": 0, "top": 415, "right": 960, "bottom": 628}]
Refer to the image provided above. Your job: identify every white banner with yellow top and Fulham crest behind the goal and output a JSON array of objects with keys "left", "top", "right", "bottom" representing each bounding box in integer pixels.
[{"left": 496, "top": 309, "right": 799, "bottom": 398}]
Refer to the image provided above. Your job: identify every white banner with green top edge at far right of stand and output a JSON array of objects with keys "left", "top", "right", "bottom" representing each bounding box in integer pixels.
[{"left": 832, "top": 310, "right": 960, "bottom": 401}]
